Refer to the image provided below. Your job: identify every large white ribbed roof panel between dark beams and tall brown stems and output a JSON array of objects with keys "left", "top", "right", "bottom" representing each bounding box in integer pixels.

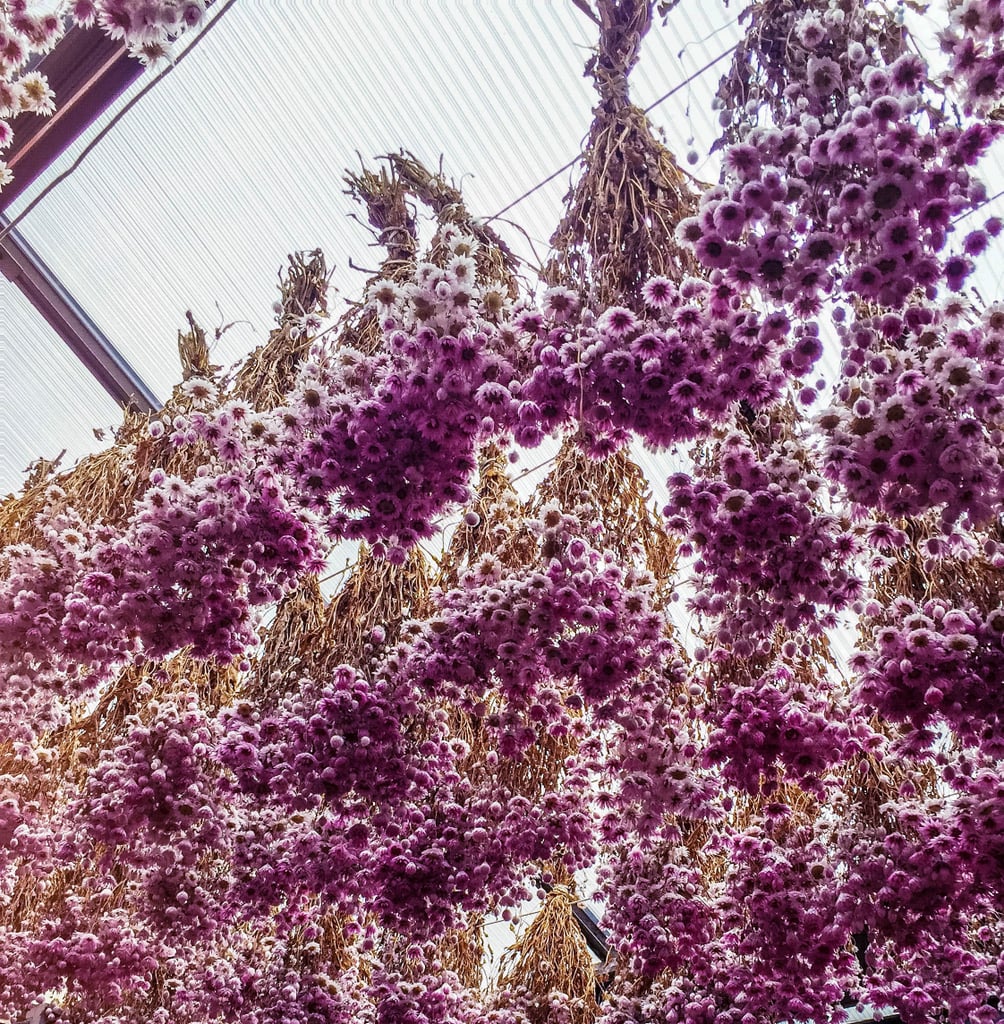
[{"left": 5, "top": 2, "right": 591, "bottom": 399}]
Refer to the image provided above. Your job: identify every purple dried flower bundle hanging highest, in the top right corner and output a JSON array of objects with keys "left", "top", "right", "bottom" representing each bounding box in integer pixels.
[{"left": 696, "top": 2, "right": 1000, "bottom": 309}]
